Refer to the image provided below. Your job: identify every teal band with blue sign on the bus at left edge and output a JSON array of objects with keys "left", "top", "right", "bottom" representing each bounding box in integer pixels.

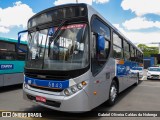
[{"left": 0, "top": 60, "right": 25, "bottom": 74}]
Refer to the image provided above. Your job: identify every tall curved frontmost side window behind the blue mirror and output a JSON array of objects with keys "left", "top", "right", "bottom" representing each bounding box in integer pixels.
[{"left": 92, "top": 18, "right": 110, "bottom": 75}]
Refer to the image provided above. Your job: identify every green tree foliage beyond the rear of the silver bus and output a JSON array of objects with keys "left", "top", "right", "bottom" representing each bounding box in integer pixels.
[{"left": 138, "top": 44, "right": 158, "bottom": 57}]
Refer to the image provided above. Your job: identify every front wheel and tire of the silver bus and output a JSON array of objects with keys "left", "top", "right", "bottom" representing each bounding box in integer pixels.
[{"left": 107, "top": 80, "right": 118, "bottom": 106}]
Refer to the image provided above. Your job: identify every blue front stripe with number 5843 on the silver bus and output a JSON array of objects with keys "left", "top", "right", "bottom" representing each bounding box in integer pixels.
[{"left": 25, "top": 77, "right": 69, "bottom": 89}]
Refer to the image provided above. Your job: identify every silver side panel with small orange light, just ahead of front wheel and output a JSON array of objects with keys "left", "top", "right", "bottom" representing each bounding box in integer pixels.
[{"left": 89, "top": 58, "right": 115, "bottom": 109}]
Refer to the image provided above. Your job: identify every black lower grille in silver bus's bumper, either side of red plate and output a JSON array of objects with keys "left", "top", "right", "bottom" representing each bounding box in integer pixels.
[{"left": 27, "top": 95, "right": 61, "bottom": 108}]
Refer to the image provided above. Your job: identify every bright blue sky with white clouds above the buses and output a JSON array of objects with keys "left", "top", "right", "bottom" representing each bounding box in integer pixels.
[{"left": 0, "top": 0, "right": 160, "bottom": 46}]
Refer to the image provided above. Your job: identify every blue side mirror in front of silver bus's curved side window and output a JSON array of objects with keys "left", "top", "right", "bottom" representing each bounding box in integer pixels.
[{"left": 97, "top": 34, "right": 105, "bottom": 51}]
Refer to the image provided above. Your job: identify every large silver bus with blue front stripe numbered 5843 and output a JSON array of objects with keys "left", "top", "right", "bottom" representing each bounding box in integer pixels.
[{"left": 18, "top": 3, "right": 143, "bottom": 112}]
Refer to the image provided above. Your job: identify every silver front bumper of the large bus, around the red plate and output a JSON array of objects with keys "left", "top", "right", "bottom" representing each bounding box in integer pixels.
[{"left": 23, "top": 87, "right": 91, "bottom": 112}]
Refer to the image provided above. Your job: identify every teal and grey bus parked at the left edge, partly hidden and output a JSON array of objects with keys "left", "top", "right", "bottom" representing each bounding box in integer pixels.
[{"left": 0, "top": 37, "right": 27, "bottom": 87}]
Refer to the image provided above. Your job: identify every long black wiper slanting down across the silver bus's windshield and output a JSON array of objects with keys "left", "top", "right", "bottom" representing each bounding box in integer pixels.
[{"left": 48, "top": 20, "right": 67, "bottom": 56}]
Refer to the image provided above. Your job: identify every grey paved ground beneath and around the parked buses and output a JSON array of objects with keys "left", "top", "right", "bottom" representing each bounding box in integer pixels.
[{"left": 0, "top": 80, "right": 160, "bottom": 120}]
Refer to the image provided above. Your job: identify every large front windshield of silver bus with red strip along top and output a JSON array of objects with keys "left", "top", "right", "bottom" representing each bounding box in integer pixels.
[{"left": 26, "top": 23, "right": 89, "bottom": 70}]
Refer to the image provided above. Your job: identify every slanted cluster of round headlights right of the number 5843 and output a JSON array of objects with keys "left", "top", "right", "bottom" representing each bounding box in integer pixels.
[{"left": 63, "top": 81, "right": 87, "bottom": 96}]
